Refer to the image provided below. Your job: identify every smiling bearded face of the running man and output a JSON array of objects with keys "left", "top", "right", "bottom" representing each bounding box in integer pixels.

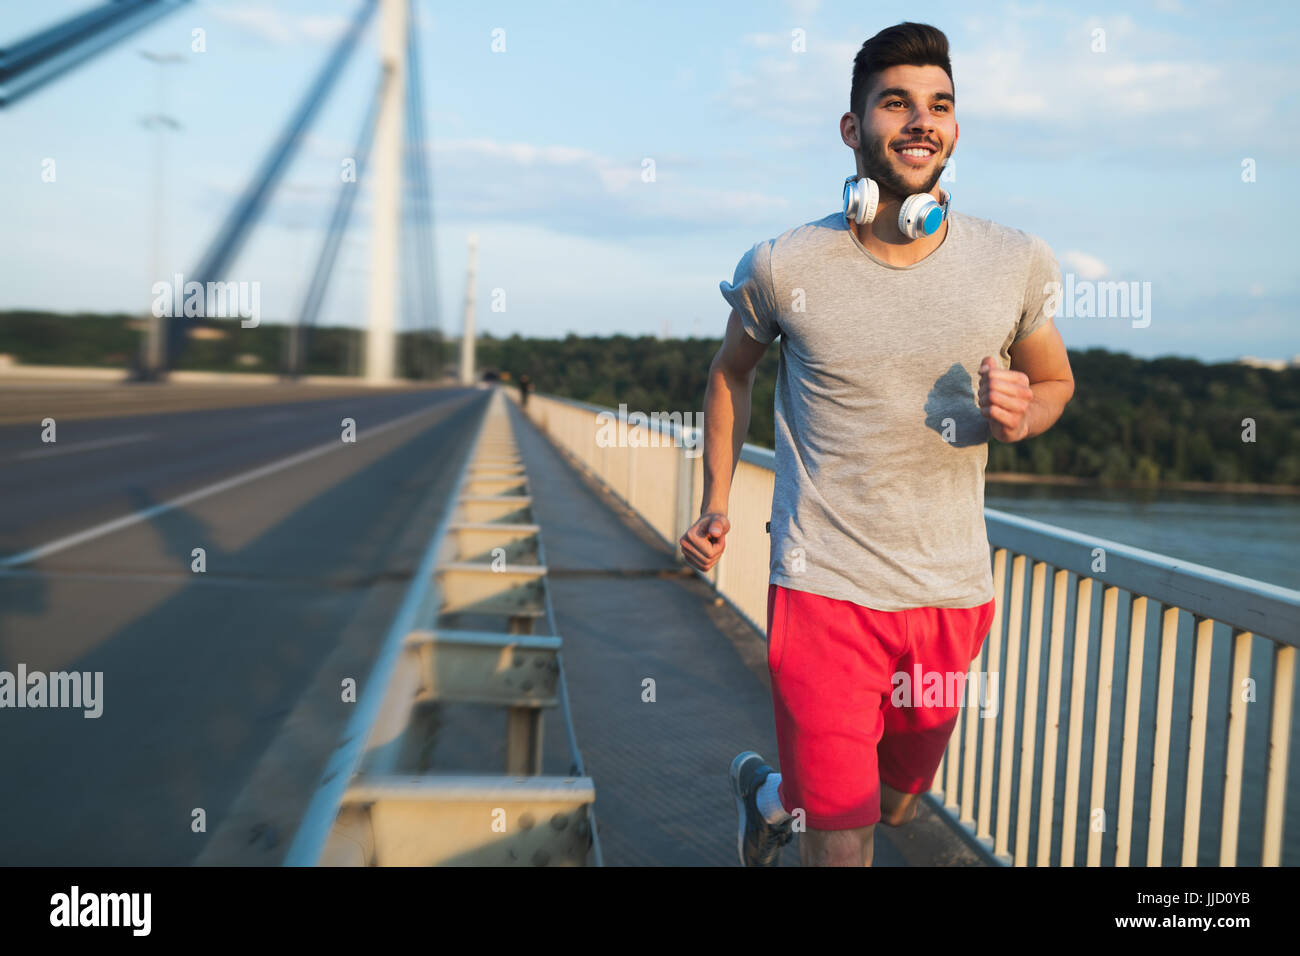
[{"left": 849, "top": 66, "right": 957, "bottom": 199}]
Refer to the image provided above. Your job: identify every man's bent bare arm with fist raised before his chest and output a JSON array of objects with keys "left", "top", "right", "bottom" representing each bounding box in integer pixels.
[{"left": 979, "top": 319, "right": 1074, "bottom": 442}]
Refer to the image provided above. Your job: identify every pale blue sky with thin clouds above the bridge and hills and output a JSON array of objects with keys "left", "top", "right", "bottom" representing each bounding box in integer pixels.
[{"left": 0, "top": 0, "right": 1300, "bottom": 360}]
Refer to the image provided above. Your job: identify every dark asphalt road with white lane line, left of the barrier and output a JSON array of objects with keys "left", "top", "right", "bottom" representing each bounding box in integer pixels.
[{"left": 0, "top": 388, "right": 488, "bottom": 865}]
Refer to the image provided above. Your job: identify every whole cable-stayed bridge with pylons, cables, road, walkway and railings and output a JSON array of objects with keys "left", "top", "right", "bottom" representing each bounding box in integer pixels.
[{"left": 0, "top": 0, "right": 1300, "bottom": 866}]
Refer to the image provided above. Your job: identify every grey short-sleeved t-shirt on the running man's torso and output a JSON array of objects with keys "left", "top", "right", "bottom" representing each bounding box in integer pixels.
[{"left": 722, "top": 211, "right": 1061, "bottom": 611}]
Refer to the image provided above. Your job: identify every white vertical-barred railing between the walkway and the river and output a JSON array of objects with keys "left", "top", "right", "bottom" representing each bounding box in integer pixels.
[{"left": 511, "top": 390, "right": 1300, "bottom": 866}]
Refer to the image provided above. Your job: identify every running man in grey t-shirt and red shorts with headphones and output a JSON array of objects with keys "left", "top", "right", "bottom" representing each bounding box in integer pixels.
[{"left": 680, "top": 23, "right": 1074, "bottom": 866}]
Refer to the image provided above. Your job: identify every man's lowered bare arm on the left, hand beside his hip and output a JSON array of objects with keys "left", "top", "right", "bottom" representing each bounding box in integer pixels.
[{"left": 680, "top": 310, "right": 767, "bottom": 571}]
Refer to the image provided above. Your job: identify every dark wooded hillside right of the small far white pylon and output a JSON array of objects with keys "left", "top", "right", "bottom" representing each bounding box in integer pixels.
[{"left": 477, "top": 336, "right": 1300, "bottom": 485}]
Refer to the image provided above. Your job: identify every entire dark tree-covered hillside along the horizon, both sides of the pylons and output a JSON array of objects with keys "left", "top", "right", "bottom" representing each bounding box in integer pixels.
[{"left": 0, "top": 312, "right": 1300, "bottom": 485}]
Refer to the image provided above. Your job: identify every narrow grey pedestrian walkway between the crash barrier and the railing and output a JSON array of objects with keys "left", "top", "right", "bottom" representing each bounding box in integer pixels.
[{"left": 508, "top": 402, "right": 979, "bottom": 866}]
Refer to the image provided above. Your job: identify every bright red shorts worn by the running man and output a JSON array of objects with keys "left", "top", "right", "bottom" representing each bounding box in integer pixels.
[{"left": 767, "top": 584, "right": 993, "bottom": 830}]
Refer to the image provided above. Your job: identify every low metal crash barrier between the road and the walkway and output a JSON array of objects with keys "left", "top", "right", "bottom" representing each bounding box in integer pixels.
[{"left": 285, "top": 389, "right": 602, "bottom": 866}]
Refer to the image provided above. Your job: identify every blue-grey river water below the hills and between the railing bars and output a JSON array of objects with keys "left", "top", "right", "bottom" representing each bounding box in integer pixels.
[{"left": 966, "top": 484, "right": 1300, "bottom": 866}]
